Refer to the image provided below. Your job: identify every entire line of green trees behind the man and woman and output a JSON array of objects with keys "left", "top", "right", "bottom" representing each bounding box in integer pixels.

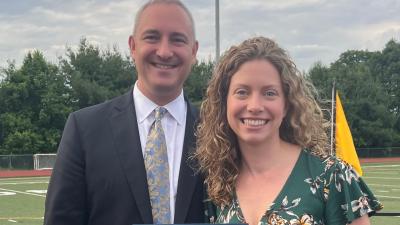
[{"left": 0, "top": 39, "right": 400, "bottom": 154}]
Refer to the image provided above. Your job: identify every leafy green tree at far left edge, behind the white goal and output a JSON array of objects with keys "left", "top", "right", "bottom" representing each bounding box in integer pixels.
[{"left": 0, "top": 51, "right": 71, "bottom": 154}]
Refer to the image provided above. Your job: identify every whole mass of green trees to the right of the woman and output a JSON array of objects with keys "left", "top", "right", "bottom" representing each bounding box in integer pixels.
[{"left": 308, "top": 41, "right": 400, "bottom": 147}]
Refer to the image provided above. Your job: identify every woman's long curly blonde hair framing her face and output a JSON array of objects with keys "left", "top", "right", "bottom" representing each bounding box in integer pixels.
[{"left": 194, "top": 37, "right": 329, "bottom": 205}]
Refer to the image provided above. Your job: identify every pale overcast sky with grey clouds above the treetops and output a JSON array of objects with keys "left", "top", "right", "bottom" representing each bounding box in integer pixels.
[{"left": 0, "top": 0, "right": 400, "bottom": 71}]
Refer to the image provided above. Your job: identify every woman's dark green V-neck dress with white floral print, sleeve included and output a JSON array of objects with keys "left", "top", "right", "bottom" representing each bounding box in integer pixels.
[{"left": 207, "top": 150, "right": 383, "bottom": 225}]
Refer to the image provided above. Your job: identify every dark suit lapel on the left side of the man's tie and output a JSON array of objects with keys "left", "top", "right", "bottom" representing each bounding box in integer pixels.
[{"left": 110, "top": 91, "right": 153, "bottom": 224}]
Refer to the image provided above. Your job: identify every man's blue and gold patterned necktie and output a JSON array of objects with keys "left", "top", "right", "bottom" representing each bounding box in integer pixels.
[{"left": 144, "top": 107, "right": 171, "bottom": 224}]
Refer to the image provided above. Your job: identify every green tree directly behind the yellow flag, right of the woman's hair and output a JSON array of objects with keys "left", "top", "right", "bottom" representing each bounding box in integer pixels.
[{"left": 308, "top": 46, "right": 399, "bottom": 147}]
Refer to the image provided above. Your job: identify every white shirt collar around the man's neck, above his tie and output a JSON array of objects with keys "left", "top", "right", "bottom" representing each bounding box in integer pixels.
[{"left": 133, "top": 82, "right": 186, "bottom": 125}]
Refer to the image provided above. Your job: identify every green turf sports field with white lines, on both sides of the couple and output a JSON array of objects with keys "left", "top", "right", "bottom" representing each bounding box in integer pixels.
[{"left": 0, "top": 162, "right": 400, "bottom": 225}]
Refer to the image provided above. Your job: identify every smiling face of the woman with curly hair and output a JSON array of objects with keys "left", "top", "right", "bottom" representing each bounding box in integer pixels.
[{"left": 227, "top": 59, "right": 286, "bottom": 145}]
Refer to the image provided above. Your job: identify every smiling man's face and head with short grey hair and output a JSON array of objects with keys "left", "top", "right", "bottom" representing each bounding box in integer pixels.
[{"left": 129, "top": 4, "right": 198, "bottom": 104}]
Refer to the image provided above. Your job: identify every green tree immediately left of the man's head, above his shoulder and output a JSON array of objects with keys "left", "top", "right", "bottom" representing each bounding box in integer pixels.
[{"left": 60, "top": 39, "right": 136, "bottom": 109}]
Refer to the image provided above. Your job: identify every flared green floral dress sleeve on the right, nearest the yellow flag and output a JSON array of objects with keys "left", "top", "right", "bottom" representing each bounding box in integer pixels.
[{"left": 324, "top": 158, "right": 383, "bottom": 225}]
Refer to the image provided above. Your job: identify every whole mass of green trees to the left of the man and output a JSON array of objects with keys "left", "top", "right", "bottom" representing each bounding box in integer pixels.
[{"left": 0, "top": 39, "right": 136, "bottom": 154}]
